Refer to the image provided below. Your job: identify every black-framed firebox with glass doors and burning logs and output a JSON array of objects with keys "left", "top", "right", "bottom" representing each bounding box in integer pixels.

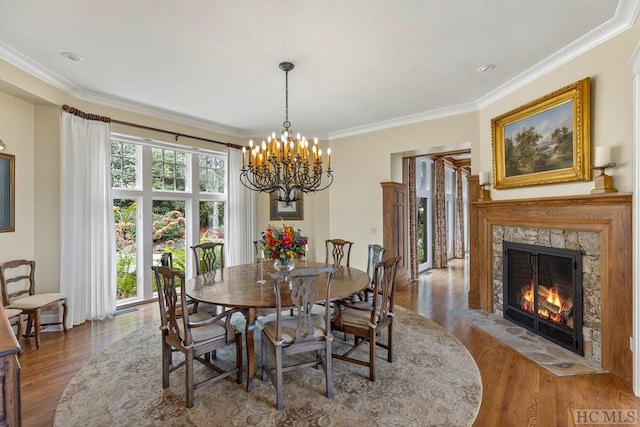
[{"left": 502, "top": 241, "right": 584, "bottom": 355}]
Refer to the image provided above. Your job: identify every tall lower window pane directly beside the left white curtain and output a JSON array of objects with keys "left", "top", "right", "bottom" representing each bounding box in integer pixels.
[{"left": 113, "top": 199, "right": 138, "bottom": 300}]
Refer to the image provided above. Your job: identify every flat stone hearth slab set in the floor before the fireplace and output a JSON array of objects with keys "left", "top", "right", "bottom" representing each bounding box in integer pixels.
[{"left": 454, "top": 310, "right": 607, "bottom": 376}]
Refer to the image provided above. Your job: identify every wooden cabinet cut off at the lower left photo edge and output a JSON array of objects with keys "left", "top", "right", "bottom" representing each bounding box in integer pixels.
[{"left": 0, "top": 306, "right": 22, "bottom": 427}]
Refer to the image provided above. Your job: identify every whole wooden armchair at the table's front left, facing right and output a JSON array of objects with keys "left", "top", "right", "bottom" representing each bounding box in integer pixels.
[{"left": 152, "top": 266, "right": 242, "bottom": 408}]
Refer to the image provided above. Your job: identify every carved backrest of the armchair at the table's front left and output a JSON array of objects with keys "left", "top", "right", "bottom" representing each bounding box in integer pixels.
[{"left": 151, "top": 266, "right": 193, "bottom": 346}]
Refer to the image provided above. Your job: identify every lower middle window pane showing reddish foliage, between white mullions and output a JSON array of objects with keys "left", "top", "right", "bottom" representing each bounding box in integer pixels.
[{"left": 152, "top": 200, "right": 186, "bottom": 272}]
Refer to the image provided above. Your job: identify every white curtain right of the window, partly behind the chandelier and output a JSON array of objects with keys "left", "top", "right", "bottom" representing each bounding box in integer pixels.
[{"left": 225, "top": 148, "right": 258, "bottom": 266}]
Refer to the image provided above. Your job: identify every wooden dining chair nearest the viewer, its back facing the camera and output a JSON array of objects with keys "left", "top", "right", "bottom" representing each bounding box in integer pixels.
[{"left": 261, "top": 267, "right": 335, "bottom": 410}]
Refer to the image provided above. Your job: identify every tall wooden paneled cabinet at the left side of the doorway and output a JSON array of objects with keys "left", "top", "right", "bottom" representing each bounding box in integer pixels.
[{"left": 381, "top": 182, "right": 409, "bottom": 284}]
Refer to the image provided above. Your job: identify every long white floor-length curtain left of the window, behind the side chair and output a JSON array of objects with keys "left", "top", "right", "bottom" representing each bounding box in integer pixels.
[{"left": 60, "top": 112, "right": 116, "bottom": 327}]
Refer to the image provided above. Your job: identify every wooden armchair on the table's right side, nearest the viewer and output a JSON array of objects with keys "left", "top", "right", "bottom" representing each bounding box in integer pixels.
[{"left": 331, "top": 257, "right": 398, "bottom": 381}]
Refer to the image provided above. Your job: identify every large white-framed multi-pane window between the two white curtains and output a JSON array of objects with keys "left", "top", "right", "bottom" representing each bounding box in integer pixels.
[{"left": 111, "top": 135, "right": 227, "bottom": 304}]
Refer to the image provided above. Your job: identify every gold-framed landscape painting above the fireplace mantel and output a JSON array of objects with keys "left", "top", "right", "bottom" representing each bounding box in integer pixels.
[{"left": 491, "top": 77, "right": 591, "bottom": 189}]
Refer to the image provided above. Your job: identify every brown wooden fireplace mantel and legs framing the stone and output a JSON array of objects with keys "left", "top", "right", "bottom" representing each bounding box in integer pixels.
[{"left": 469, "top": 192, "right": 633, "bottom": 383}]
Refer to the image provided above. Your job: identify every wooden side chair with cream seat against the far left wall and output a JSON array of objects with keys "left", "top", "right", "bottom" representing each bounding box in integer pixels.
[{"left": 0, "top": 259, "right": 67, "bottom": 349}]
